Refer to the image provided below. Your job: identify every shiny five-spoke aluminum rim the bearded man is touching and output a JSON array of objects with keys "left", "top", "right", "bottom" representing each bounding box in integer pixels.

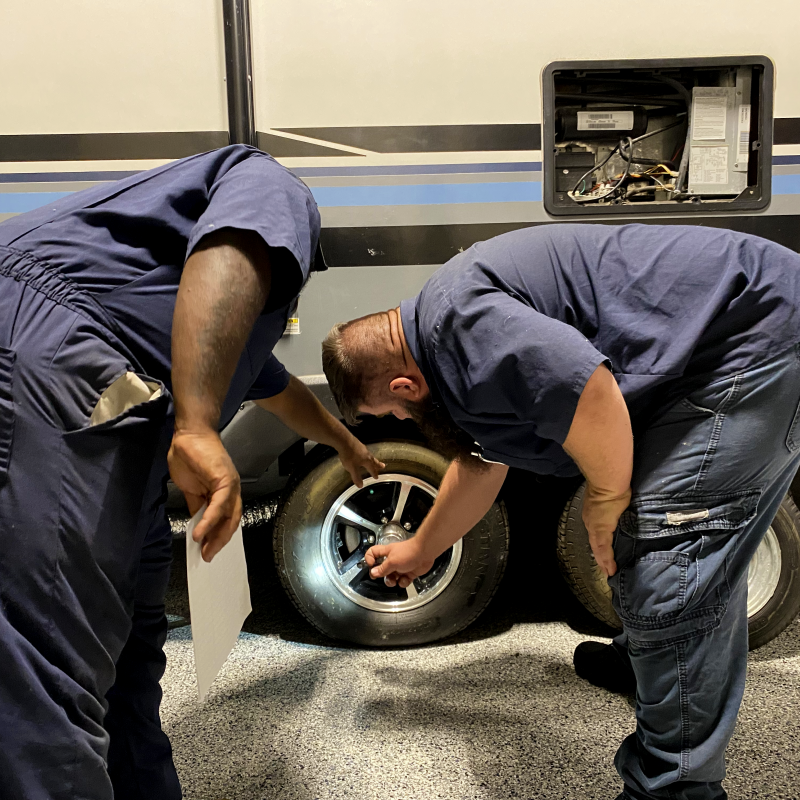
[{"left": 320, "top": 473, "right": 462, "bottom": 614}]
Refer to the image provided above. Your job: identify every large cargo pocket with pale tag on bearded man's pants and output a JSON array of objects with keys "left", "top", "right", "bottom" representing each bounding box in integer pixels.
[{"left": 610, "top": 489, "right": 760, "bottom": 647}]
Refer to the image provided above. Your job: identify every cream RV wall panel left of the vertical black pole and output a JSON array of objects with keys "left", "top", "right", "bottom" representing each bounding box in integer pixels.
[{"left": 0, "top": 0, "right": 228, "bottom": 134}]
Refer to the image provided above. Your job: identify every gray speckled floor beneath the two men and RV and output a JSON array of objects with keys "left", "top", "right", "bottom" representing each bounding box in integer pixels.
[{"left": 163, "top": 490, "right": 800, "bottom": 800}]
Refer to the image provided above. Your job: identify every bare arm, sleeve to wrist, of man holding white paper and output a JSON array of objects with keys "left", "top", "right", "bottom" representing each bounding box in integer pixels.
[{"left": 172, "top": 230, "right": 271, "bottom": 431}]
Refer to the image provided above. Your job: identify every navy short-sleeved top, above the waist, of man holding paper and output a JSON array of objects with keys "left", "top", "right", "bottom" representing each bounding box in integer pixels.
[{"left": 0, "top": 145, "right": 320, "bottom": 425}]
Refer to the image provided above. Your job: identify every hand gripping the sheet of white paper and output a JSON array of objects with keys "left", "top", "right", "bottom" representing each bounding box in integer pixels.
[{"left": 168, "top": 430, "right": 242, "bottom": 561}]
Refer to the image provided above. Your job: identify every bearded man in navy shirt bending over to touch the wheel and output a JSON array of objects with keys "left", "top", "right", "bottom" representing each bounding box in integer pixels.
[{"left": 323, "top": 225, "right": 800, "bottom": 800}]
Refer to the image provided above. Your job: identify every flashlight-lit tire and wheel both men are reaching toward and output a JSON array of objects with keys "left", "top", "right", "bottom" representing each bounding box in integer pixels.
[{"left": 273, "top": 442, "right": 509, "bottom": 647}]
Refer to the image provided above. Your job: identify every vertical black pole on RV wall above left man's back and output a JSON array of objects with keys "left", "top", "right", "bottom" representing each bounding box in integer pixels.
[{"left": 222, "top": 0, "right": 257, "bottom": 145}]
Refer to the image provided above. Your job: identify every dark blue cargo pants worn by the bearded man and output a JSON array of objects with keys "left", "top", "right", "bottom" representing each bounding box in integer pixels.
[{"left": 609, "top": 343, "right": 800, "bottom": 800}]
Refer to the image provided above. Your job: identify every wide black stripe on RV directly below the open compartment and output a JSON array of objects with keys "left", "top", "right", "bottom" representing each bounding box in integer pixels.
[{"left": 322, "top": 214, "right": 800, "bottom": 267}]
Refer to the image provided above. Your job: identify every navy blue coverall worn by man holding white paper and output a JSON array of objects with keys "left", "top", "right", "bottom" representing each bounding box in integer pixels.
[{"left": 0, "top": 145, "right": 321, "bottom": 800}]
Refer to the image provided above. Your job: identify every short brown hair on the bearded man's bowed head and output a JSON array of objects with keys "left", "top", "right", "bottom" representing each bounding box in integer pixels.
[{"left": 322, "top": 312, "right": 403, "bottom": 425}]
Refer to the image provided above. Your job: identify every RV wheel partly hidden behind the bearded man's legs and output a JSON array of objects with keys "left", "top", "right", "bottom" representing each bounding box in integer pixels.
[{"left": 557, "top": 486, "right": 800, "bottom": 650}]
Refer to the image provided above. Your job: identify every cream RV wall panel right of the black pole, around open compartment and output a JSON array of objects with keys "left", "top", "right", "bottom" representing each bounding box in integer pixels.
[{"left": 251, "top": 0, "right": 800, "bottom": 131}]
